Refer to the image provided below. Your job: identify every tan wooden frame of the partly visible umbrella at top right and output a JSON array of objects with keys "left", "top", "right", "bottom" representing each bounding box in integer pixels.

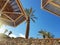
[{"left": 41, "top": 0, "right": 60, "bottom": 16}]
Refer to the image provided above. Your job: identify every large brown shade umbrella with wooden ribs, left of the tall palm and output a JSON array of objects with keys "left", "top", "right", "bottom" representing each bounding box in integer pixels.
[{"left": 0, "top": 0, "right": 27, "bottom": 27}]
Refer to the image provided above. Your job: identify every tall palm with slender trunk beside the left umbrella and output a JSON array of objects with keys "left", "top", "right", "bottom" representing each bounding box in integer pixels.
[{"left": 25, "top": 8, "right": 36, "bottom": 39}]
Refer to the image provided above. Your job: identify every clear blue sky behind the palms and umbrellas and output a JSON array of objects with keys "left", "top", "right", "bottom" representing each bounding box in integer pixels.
[{"left": 7, "top": 0, "right": 60, "bottom": 38}]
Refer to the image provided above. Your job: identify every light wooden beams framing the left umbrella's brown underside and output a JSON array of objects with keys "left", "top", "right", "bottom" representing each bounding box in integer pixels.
[{"left": 0, "top": 0, "right": 27, "bottom": 26}]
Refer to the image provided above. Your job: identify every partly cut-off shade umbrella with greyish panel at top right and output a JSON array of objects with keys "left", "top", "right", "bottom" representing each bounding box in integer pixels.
[{"left": 42, "top": 0, "right": 60, "bottom": 16}]
